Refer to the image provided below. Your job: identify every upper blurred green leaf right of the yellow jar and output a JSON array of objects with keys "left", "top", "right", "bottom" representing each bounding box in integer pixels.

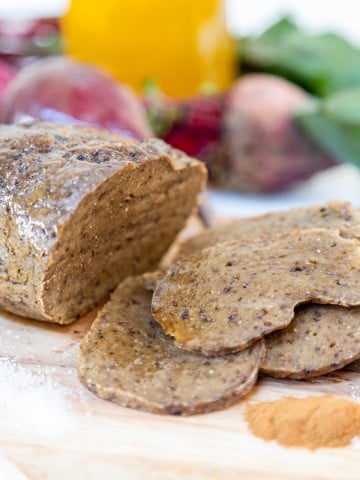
[{"left": 240, "top": 17, "right": 360, "bottom": 96}]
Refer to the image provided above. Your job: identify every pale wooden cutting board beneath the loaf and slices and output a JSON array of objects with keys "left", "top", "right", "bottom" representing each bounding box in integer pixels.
[{"left": 0, "top": 306, "right": 360, "bottom": 480}]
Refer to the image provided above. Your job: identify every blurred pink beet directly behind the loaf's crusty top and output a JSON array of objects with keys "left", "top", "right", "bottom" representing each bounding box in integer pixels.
[{"left": 0, "top": 57, "right": 151, "bottom": 138}]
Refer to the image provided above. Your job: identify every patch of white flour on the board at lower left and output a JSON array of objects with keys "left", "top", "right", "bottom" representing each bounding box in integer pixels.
[{"left": 0, "top": 358, "right": 74, "bottom": 438}]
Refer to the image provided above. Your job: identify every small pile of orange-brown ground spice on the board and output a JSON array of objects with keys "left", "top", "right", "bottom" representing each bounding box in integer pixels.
[{"left": 245, "top": 396, "right": 360, "bottom": 450}]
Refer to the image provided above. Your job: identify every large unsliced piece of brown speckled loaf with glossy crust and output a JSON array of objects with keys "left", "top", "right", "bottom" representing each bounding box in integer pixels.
[{"left": 0, "top": 124, "right": 206, "bottom": 323}]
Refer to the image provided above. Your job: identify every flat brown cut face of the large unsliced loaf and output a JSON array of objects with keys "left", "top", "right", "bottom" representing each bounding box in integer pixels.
[{"left": 43, "top": 143, "right": 204, "bottom": 323}]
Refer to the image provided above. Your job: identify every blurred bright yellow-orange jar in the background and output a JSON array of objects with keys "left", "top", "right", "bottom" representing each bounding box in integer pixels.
[{"left": 62, "top": 0, "right": 235, "bottom": 98}]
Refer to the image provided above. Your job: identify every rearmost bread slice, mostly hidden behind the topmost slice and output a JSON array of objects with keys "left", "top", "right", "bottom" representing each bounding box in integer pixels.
[{"left": 177, "top": 201, "right": 360, "bottom": 258}]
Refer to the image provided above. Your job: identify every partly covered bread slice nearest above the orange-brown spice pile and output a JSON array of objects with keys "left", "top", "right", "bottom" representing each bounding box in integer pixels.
[{"left": 261, "top": 304, "right": 360, "bottom": 379}]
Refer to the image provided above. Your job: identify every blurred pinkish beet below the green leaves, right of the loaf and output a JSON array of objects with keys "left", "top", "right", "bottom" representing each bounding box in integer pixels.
[{"left": 216, "top": 74, "right": 335, "bottom": 192}]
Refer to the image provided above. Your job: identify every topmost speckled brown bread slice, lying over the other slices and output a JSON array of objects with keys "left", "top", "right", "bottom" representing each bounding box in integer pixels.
[{"left": 152, "top": 229, "right": 360, "bottom": 355}]
